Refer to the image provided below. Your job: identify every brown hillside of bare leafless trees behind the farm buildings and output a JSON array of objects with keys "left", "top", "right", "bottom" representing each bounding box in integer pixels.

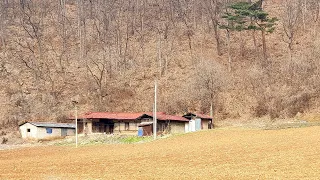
[{"left": 0, "top": 0, "right": 320, "bottom": 126}]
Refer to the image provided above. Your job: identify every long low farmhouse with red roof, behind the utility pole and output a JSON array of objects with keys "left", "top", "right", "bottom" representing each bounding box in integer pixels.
[{"left": 71, "top": 112, "right": 189, "bottom": 135}]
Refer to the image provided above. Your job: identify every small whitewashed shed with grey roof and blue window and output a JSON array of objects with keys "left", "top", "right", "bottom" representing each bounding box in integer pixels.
[{"left": 19, "top": 122, "right": 76, "bottom": 139}]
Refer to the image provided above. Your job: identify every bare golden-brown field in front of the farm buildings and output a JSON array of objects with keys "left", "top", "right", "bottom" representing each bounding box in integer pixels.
[{"left": 0, "top": 127, "right": 320, "bottom": 179}]
